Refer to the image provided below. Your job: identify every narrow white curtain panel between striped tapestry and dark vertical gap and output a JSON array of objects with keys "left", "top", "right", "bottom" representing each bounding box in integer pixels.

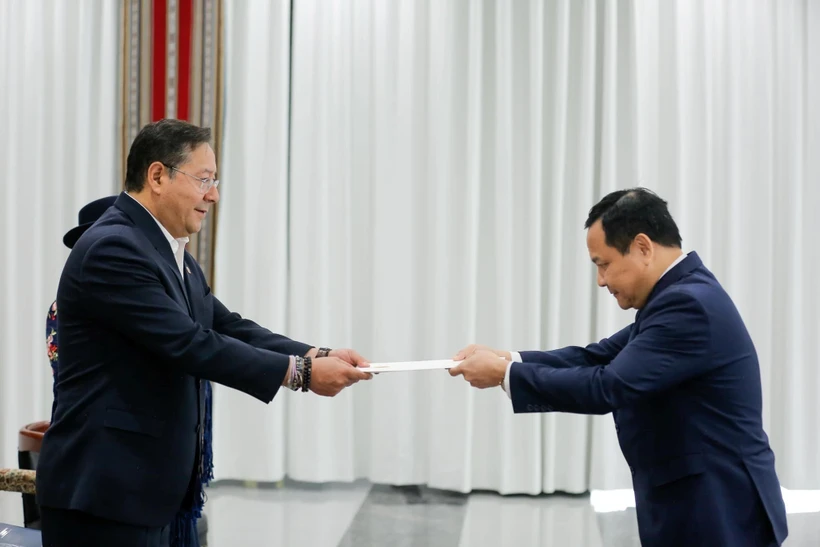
[{"left": 213, "top": 0, "right": 290, "bottom": 481}]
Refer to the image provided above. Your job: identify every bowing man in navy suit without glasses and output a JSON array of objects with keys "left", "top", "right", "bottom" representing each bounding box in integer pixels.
[{"left": 451, "top": 188, "right": 788, "bottom": 547}]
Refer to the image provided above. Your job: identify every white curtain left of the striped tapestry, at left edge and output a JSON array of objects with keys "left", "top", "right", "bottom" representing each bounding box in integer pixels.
[{"left": 0, "top": 0, "right": 121, "bottom": 467}]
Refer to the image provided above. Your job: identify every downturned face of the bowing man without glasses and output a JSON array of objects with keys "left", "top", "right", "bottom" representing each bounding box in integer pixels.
[{"left": 587, "top": 220, "right": 655, "bottom": 310}]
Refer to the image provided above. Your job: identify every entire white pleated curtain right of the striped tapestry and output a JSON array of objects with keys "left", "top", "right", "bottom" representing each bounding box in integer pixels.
[{"left": 215, "top": 0, "right": 820, "bottom": 494}]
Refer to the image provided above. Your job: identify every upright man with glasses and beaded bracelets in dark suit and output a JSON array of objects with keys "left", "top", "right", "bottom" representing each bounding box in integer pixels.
[{"left": 37, "top": 120, "right": 370, "bottom": 547}]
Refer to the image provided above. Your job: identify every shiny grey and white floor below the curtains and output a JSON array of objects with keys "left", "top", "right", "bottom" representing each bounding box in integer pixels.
[{"left": 0, "top": 482, "right": 820, "bottom": 547}]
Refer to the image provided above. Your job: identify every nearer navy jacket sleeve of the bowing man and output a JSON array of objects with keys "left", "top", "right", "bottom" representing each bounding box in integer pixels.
[{"left": 510, "top": 291, "right": 714, "bottom": 414}]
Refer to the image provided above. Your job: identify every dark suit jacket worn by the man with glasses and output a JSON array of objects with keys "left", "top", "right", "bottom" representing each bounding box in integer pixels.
[{"left": 37, "top": 194, "right": 310, "bottom": 527}]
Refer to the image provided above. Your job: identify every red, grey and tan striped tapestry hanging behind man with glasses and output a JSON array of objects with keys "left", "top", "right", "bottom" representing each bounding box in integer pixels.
[{"left": 120, "top": 0, "right": 223, "bottom": 286}]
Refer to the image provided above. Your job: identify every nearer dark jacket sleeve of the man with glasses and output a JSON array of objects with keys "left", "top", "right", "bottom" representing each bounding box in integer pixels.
[{"left": 82, "top": 235, "right": 289, "bottom": 402}]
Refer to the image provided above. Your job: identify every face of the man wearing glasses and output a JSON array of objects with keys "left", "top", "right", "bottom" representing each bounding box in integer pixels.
[{"left": 149, "top": 144, "right": 219, "bottom": 238}]
